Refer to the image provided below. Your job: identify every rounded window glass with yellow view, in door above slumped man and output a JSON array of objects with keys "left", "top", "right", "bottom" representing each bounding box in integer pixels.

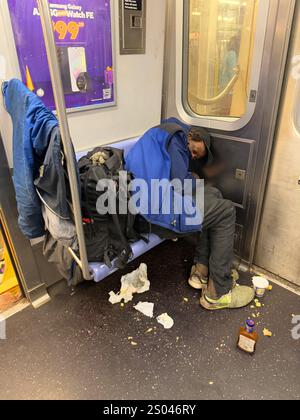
[{"left": 187, "top": 0, "right": 259, "bottom": 118}]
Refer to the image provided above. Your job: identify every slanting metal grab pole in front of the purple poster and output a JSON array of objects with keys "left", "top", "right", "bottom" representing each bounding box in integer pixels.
[{"left": 37, "top": 0, "right": 92, "bottom": 280}]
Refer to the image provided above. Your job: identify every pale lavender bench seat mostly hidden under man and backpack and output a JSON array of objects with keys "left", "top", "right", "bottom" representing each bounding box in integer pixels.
[{"left": 76, "top": 137, "right": 163, "bottom": 283}]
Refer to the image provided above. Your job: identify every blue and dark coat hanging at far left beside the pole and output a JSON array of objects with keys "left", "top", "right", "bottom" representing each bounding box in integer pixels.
[{"left": 2, "top": 79, "right": 74, "bottom": 239}]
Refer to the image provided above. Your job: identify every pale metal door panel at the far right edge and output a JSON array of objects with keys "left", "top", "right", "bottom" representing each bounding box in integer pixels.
[{"left": 255, "top": 2, "right": 300, "bottom": 286}]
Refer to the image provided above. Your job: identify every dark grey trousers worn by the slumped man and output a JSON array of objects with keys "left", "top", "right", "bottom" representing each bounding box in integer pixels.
[{"left": 194, "top": 187, "right": 236, "bottom": 297}]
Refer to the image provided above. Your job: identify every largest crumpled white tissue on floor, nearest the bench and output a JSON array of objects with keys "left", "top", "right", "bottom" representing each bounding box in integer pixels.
[{"left": 109, "top": 264, "right": 150, "bottom": 305}]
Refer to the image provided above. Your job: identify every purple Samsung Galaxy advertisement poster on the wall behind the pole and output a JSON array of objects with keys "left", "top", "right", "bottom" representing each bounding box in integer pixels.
[{"left": 7, "top": 0, "right": 115, "bottom": 111}]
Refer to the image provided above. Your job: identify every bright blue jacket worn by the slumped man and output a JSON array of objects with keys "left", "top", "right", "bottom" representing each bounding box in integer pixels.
[{"left": 126, "top": 120, "right": 203, "bottom": 234}]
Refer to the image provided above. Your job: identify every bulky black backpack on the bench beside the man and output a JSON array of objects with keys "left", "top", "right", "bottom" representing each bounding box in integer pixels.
[{"left": 78, "top": 147, "right": 138, "bottom": 268}]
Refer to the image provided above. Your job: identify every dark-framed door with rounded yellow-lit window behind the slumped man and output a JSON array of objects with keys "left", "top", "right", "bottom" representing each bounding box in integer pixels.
[{"left": 163, "top": 0, "right": 295, "bottom": 267}]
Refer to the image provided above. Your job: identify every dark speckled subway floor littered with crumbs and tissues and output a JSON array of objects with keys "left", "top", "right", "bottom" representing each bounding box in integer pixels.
[{"left": 0, "top": 240, "right": 300, "bottom": 400}]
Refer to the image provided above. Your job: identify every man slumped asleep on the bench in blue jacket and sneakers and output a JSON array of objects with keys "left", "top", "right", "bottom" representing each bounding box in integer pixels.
[{"left": 126, "top": 122, "right": 254, "bottom": 311}]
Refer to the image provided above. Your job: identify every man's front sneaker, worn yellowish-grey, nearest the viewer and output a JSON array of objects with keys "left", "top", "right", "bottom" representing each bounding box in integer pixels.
[{"left": 200, "top": 286, "right": 255, "bottom": 311}]
